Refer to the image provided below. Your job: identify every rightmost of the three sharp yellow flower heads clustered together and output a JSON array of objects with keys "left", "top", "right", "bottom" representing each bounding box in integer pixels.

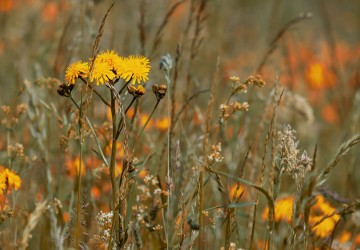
[{"left": 121, "top": 56, "right": 150, "bottom": 84}]
